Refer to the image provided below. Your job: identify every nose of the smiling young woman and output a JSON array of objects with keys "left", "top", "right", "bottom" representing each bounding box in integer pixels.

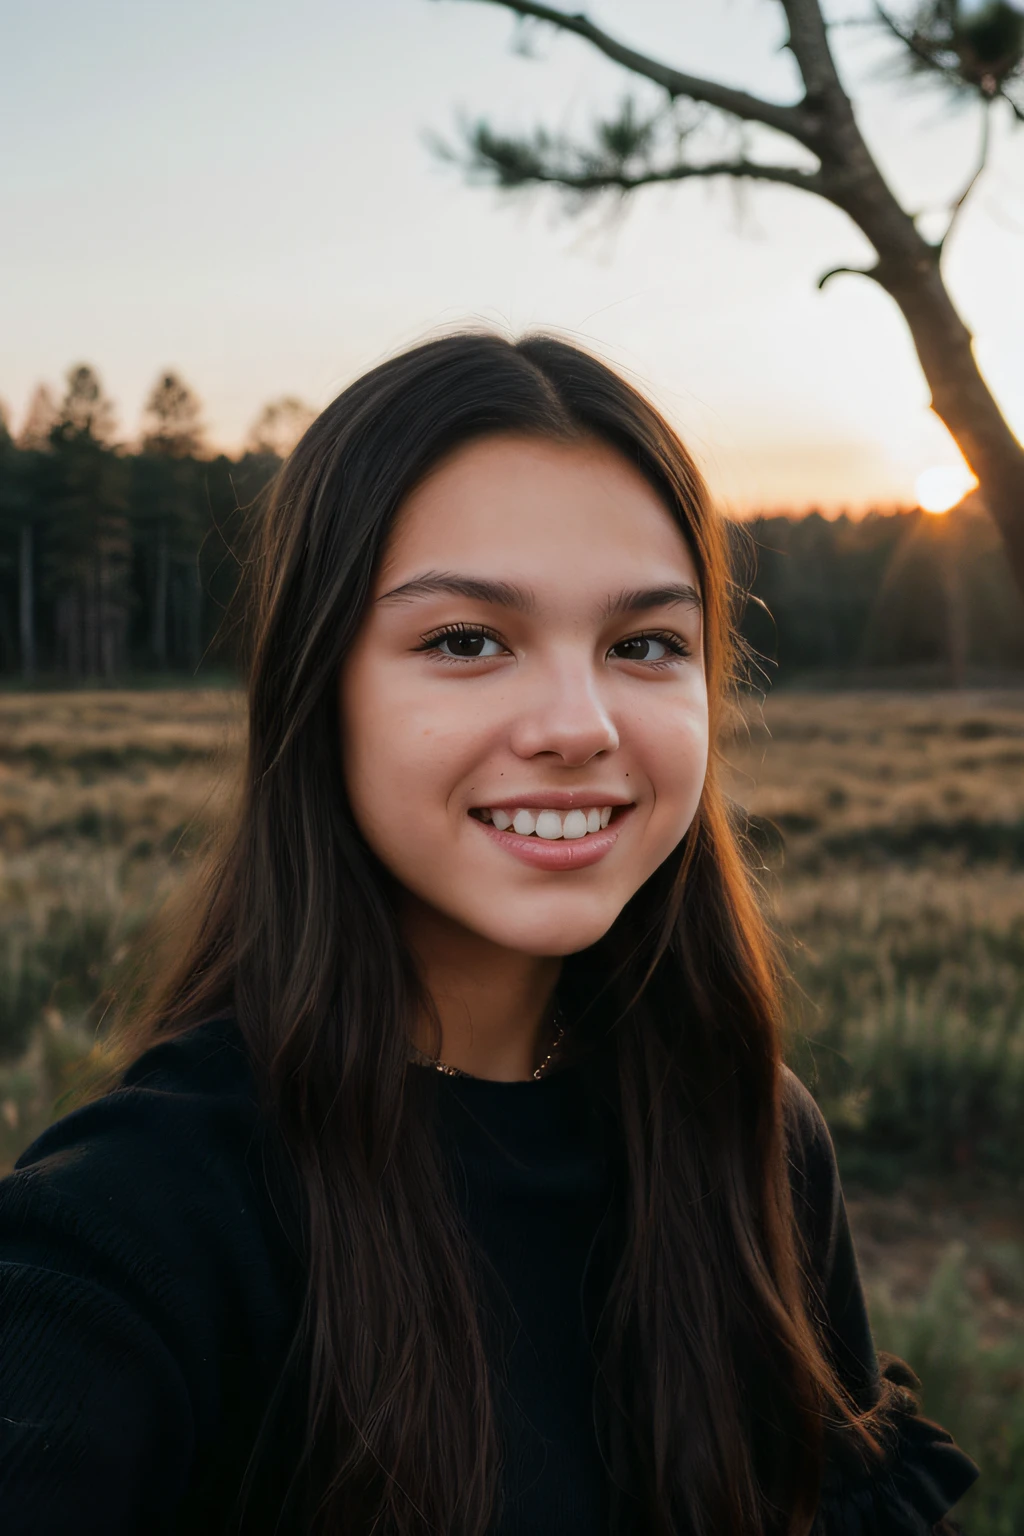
[{"left": 510, "top": 665, "right": 619, "bottom": 768}]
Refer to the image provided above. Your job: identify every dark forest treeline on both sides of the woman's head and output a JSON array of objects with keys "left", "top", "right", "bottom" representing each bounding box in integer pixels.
[{"left": 0, "top": 366, "right": 1024, "bottom": 684}]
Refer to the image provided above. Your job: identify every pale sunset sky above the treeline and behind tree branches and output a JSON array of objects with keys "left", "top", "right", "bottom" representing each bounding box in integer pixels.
[{"left": 0, "top": 0, "right": 1024, "bottom": 511}]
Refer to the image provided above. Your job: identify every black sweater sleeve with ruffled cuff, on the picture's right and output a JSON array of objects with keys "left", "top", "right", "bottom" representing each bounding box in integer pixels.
[{"left": 786, "top": 1074, "right": 978, "bottom": 1536}]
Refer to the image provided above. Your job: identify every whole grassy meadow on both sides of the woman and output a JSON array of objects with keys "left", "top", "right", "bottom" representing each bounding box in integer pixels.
[{"left": 0, "top": 690, "right": 1024, "bottom": 1536}]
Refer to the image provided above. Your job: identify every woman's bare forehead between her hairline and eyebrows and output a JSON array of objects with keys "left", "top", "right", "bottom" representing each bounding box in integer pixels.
[{"left": 379, "top": 436, "right": 697, "bottom": 590}]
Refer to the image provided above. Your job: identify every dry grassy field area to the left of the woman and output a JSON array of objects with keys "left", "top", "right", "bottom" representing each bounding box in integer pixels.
[{"left": 0, "top": 690, "right": 243, "bottom": 1166}]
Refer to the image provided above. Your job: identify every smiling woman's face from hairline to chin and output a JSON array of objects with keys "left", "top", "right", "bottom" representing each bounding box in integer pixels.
[{"left": 341, "top": 436, "right": 708, "bottom": 955}]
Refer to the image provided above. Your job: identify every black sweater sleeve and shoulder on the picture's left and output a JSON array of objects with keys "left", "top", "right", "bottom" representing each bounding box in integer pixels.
[{"left": 0, "top": 1032, "right": 296, "bottom": 1536}]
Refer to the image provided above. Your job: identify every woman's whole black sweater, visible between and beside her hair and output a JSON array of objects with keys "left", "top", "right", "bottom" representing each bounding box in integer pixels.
[{"left": 0, "top": 1020, "right": 976, "bottom": 1536}]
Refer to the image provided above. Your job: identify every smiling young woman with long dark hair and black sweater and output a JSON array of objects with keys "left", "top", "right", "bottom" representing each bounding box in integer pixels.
[{"left": 0, "top": 335, "right": 975, "bottom": 1536}]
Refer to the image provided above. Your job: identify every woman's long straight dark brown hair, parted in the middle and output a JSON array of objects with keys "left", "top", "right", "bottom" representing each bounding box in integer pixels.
[{"left": 110, "top": 335, "right": 870, "bottom": 1536}]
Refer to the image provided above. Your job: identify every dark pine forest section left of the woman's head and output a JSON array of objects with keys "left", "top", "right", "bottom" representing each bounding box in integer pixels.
[{"left": 0, "top": 364, "right": 312, "bottom": 682}]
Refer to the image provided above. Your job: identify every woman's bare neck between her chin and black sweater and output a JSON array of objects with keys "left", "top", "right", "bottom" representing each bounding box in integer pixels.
[{"left": 402, "top": 897, "right": 562, "bottom": 1083}]
